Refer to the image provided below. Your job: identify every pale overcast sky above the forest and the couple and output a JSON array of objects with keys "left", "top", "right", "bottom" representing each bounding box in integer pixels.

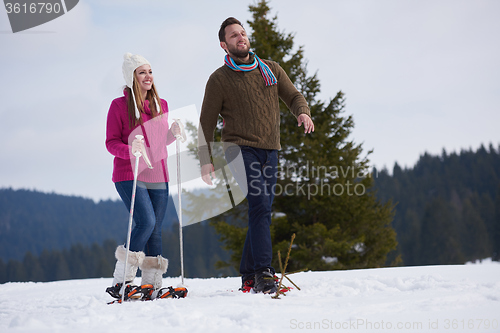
[{"left": 0, "top": 0, "right": 500, "bottom": 200}]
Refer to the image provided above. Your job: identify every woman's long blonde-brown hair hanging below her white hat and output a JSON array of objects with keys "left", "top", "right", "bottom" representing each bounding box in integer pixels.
[{"left": 125, "top": 71, "right": 164, "bottom": 128}]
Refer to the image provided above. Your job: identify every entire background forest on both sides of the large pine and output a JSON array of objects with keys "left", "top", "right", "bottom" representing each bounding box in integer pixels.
[{"left": 0, "top": 145, "right": 500, "bottom": 283}]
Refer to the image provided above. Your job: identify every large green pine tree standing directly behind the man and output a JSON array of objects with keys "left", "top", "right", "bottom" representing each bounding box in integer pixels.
[{"left": 211, "top": 0, "right": 397, "bottom": 270}]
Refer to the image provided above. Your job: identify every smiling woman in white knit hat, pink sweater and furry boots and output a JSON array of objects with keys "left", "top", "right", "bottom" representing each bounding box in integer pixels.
[{"left": 106, "top": 53, "right": 180, "bottom": 298}]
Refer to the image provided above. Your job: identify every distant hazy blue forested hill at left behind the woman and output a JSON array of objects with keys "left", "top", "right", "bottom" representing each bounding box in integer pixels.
[{"left": 0, "top": 188, "right": 144, "bottom": 260}]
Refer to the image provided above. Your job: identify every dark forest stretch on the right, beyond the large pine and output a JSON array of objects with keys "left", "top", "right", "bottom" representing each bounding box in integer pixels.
[{"left": 374, "top": 144, "right": 500, "bottom": 265}]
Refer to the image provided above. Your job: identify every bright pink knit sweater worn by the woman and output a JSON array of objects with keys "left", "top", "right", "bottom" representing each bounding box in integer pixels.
[{"left": 106, "top": 91, "right": 175, "bottom": 183}]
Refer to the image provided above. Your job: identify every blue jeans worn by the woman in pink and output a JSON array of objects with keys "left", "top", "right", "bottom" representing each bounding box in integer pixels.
[{"left": 115, "top": 180, "right": 168, "bottom": 256}]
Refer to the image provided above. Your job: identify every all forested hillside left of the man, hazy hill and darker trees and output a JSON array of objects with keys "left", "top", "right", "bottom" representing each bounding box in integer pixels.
[{"left": 0, "top": 189, "right": 235, "bottom": 283}]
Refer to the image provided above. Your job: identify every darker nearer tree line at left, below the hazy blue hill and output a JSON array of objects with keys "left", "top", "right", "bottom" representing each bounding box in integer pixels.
[{"left": 0, "top": 223, "right": 235, "bottom": 283}]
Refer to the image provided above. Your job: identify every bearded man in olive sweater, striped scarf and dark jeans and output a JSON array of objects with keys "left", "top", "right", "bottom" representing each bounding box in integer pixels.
[{"left": 198, "top": 17, "right": 314, "bottom": 293}]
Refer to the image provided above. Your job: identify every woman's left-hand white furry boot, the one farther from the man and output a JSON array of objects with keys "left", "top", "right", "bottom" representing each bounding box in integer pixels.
[{"left": 106, "top": 245, "right": 146, "bottom": 298}]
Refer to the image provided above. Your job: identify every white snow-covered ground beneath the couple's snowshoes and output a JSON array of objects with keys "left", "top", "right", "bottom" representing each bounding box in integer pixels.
[{"left": 0, "top": 261, "right": 500, "bottom": 333}]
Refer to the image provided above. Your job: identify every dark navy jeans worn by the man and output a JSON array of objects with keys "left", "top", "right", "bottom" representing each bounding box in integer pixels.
[{"left": 226, "top": 146, "right": 278, "bottom": 280}]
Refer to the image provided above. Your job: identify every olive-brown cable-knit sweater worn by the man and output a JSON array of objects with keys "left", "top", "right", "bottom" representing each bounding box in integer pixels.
[{"left": 198, "top": 56, "right": 311, "bottom": 165}]
